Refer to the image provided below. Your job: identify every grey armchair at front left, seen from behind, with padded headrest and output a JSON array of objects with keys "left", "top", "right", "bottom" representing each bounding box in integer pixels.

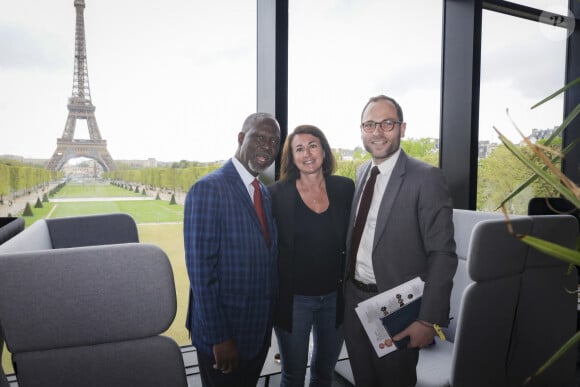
[{"left": 0, "top": 243, "right": 187, "bottom": 387}]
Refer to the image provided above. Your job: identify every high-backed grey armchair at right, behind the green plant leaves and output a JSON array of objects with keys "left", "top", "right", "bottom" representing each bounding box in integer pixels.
[{"left": 417, "top": 210, "right": 578, "bottom": 387}]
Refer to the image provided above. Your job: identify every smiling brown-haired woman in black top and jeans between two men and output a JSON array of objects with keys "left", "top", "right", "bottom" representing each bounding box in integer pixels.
[{"left": 269, "top": 125, "right": 354, "bottom": 387}]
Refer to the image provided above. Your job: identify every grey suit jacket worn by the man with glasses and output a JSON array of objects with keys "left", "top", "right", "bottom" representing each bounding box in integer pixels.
[{"left": 346, "top": 150, "right": 457, "bottom": 326}]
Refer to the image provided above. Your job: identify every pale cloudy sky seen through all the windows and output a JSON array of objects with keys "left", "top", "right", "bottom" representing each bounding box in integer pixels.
[{"left": 0, "top": 0, "right": 567, "bottom": 161}]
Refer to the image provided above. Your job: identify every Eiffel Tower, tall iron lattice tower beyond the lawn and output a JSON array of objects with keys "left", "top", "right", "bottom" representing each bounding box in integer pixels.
[{"left": 47, "top": 0, "right": 115, "bottom": 171}]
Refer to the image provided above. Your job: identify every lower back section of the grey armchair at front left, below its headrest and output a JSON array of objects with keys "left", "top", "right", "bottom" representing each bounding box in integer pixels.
[{"left": 14, "top": 336, "right": 186, "bottom": 387}]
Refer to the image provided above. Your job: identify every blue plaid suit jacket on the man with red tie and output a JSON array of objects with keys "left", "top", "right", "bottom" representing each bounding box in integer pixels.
[{"left": 184, "top": 160, "right": 277, "bottom": 359}]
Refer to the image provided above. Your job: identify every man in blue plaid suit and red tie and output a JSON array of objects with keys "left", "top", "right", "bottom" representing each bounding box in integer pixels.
[{"left": 184, "top": 113, "right": 280, "bottom": 387}]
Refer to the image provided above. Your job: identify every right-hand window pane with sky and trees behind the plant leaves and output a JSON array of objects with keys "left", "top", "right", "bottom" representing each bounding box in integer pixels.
[{"left": 477, "top": 11, "right": 567, "bottom": 214}]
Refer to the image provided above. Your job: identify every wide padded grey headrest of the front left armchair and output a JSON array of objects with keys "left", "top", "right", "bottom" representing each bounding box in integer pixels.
[{"left": 0, "top": 243, "right": 176, "bottom": 352}]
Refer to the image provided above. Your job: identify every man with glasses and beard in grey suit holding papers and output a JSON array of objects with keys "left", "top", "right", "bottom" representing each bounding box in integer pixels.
[{"left": 344, "top": 95, "right": 457, "bottom": 387}]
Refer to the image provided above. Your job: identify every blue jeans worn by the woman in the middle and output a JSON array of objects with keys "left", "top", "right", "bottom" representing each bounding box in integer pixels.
[{"left": 274, "top": 292, "right": 344, "bottom": 387}]
